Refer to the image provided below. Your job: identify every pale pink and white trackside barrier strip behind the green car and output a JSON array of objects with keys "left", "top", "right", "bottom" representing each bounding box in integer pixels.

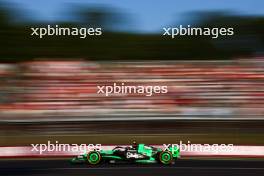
[{"left": 0, "top": 145, "right": 264, "bottom": 158}]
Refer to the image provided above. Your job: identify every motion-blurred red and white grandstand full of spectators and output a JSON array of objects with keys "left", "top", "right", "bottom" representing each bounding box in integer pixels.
[{"left": 0, "top": 58, "right": 264, "bottom": 121}]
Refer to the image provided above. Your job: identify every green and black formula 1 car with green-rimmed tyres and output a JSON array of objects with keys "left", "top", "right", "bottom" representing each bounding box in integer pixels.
[{"left": 71, "top": 144, "right": 180, "bottom": 165}]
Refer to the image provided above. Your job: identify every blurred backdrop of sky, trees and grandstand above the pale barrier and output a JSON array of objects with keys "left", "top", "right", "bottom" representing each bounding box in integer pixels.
[{"left": 0, "top": 0, "right": 264, "bottom": 146}]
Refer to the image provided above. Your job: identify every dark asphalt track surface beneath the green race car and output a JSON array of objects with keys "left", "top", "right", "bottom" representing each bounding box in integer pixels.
[{"left": 0, "top": 159, "right": 264, "bottom": 176}]
